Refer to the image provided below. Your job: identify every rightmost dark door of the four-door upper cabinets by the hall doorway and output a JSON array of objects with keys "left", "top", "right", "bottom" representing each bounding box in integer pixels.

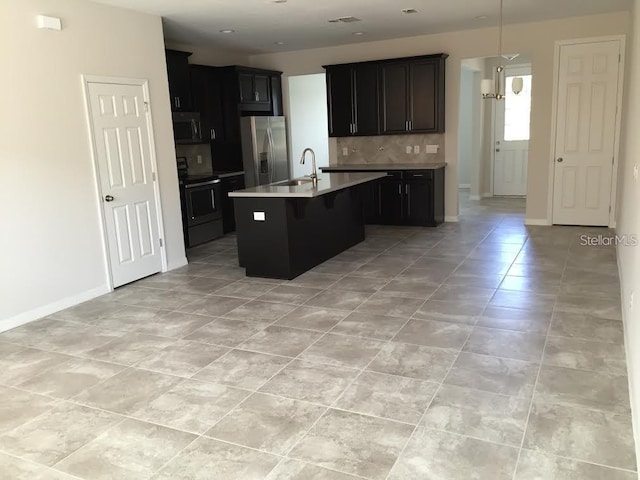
[{"left": 409, "top": 60, "right": 439, "bottom": 133}]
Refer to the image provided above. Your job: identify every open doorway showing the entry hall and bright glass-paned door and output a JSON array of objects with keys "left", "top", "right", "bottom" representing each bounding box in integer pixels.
[{"left": 458, "top": 54, "right": 534, "bottom": 218}]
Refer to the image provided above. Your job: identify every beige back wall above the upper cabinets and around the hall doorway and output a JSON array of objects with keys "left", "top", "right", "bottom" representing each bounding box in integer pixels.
[{"left": 251, "top": 12, "right": 629, "bottom": 220}]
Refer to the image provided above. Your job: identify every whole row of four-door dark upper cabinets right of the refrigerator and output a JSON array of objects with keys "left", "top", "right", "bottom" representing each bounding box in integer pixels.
[{"left": 325, "top": 53, "right": 448, "bottom": 137}]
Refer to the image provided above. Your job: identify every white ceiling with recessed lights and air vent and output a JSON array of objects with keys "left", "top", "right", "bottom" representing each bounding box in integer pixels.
[{"left": 90, "top": 0, "right": 631, "bottom": 53}]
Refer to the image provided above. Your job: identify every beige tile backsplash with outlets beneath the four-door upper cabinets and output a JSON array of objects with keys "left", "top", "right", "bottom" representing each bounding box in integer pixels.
[{"left": 337, "top": 133, "right": 445, "bottom": 165}]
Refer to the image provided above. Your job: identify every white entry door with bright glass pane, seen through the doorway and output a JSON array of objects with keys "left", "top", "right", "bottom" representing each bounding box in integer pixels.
[{"left": 493, "top": 67, "right": 532, "bottom": 197}]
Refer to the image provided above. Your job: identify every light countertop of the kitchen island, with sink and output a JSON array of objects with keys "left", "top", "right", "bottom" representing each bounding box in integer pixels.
[{"left": 229, "top": 172, "right": 385, "bottom": 198}]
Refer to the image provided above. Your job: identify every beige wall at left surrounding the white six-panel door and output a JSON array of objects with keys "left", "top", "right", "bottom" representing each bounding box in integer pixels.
[{"left": 0, "top": 0, "right": 186, "bottom": 330}]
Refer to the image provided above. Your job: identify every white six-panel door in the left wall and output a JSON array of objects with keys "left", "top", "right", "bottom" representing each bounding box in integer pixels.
[{"left": 87, "top": 82, "right": 162, "bottom": 287}]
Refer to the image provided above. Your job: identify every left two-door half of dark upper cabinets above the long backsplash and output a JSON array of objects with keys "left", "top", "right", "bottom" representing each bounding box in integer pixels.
[{"left": 325, "top": 63, "right": 380, "bottom": 137}]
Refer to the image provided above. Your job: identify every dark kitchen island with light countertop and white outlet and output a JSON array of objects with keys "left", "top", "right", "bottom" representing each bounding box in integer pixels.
[{"left": 229, "top": 172, "right": 385, "bottom": 280}]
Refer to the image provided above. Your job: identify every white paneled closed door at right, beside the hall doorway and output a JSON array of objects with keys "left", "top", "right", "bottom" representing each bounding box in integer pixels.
[{"left": 553, "top": 40, "right": 621, "bottom": 226}]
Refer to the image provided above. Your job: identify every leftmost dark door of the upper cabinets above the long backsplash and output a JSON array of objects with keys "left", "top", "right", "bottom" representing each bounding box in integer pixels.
[{"left": 327, "top": 67, "right": 353, "bottom": 137}]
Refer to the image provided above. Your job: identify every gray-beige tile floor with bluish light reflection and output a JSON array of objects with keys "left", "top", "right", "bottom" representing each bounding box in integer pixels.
[{"left": 0, "top": 193, "right": 636, "bottom": 480}]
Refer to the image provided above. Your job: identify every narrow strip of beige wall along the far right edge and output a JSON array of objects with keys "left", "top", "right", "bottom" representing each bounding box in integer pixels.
[{"left": 617, "top": 0, "right": 640, "bottom": 458}]
